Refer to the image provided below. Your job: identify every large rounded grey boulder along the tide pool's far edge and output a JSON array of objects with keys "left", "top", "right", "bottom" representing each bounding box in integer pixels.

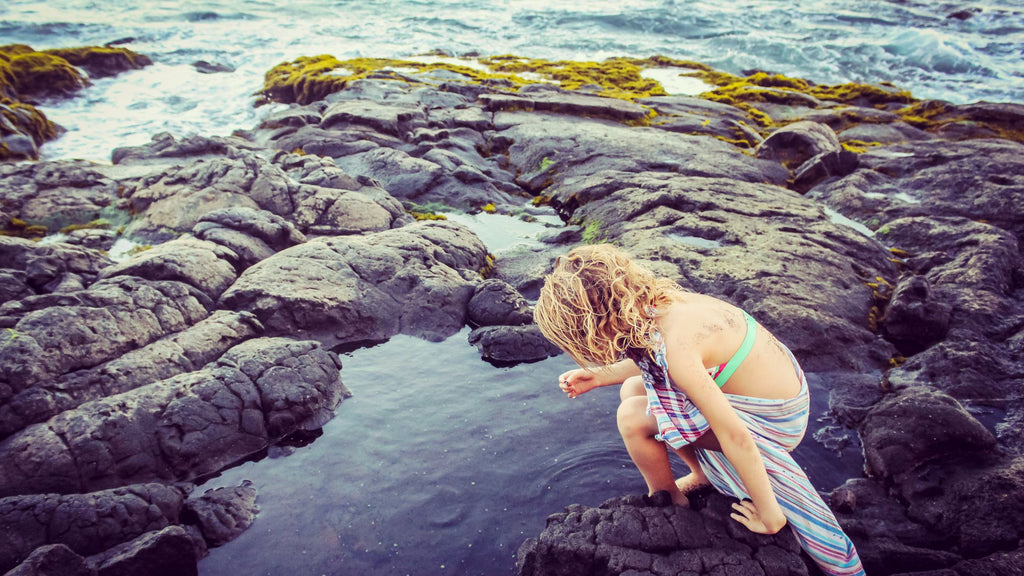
[{"left": 220, "top": 221, "right": 486, "bottom": 343}]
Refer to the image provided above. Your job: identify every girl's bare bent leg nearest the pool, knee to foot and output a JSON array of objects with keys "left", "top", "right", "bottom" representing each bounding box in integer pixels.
[{"left": 616, "top": 396, "right": 689, "bottom": 506}]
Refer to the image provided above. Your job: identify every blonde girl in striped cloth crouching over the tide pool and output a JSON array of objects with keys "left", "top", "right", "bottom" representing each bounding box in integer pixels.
[{"left": 535, "top": 244, "right": 863, "bottom": 576}]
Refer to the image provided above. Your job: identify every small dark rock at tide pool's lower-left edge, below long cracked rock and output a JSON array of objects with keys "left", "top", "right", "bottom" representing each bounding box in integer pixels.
[{"left": 185, "top": 481, "right": 259, "bottom": 546}]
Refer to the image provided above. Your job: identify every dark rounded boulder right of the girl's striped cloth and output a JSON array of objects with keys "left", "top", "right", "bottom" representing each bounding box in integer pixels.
[{"left": 860, "top": 387, "right": 995, "bottom": 482}]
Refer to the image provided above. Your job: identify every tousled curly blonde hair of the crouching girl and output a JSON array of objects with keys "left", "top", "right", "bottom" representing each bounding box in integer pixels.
[{"left": 534, "top": 244, "right": 683, "bottom": 367}]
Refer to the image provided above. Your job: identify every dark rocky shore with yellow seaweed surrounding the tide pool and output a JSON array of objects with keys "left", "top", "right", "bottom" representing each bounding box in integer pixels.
[{"left": 0, "top": 46, "right": 1024, "bottom": 576}]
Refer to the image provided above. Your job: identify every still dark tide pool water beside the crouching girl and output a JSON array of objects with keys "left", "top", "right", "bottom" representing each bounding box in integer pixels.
[{"left": 200, "top": 330, "right": 861, "bottom": 576}]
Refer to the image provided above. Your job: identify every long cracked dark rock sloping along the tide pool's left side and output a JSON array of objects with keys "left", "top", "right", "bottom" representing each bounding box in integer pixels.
[{"left": 0, "top": 338, "right": 348, "bottom": 495}]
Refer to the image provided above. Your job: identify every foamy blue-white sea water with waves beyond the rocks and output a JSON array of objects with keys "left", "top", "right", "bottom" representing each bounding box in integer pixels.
[{"left": 0, "top": 0, "right": 1024, "bottom": 162}]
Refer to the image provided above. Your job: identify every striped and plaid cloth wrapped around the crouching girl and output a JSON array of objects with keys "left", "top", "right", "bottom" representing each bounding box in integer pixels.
[{"left": 629, "top": 331, "right": 864, "bottom": 576}]
